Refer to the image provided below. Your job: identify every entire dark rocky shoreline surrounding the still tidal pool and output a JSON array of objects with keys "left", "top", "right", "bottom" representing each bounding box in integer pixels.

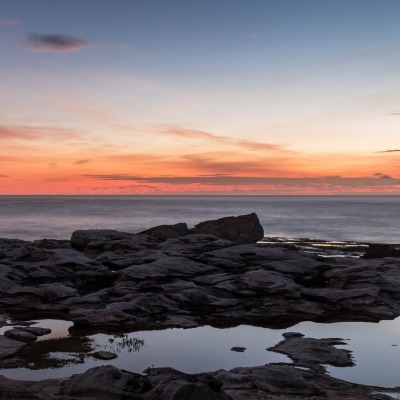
[{"left": 0, "top": 213, "right": 400, "bottom": 400}]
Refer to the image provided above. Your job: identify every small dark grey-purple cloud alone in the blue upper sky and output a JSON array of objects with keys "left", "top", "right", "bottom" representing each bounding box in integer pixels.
[{"left": 27, "top": 33, "right": 91, "bottom": 53}]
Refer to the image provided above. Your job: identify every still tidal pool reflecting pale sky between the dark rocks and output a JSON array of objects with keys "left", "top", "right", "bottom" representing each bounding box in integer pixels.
[{"left": 0, "top": 318, "right": 400, "bottom": 387}]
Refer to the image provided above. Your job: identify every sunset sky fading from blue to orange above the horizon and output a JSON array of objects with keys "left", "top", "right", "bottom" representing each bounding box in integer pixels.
[{"left": 0, "top": 0, "right": 400, "bottom": 195}]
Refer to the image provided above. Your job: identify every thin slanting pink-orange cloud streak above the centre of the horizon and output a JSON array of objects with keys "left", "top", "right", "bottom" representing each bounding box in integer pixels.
[{"left": 161, "top": 127, "right": 288, "bottom": 151}]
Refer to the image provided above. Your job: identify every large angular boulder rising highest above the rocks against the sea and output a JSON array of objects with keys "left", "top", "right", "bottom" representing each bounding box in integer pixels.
[{"left": 190, "top": 213, "right": 264, "bottom": 244}]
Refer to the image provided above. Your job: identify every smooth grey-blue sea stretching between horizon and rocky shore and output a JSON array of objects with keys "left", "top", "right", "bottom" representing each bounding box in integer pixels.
[{"left": 0, "top": 196, "right": 400, "bottom": 244}]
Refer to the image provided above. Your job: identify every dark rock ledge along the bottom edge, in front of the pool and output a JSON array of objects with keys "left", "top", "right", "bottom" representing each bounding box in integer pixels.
[{"left": 0, "top": 364, "right": 396, "bottom": 400}]
